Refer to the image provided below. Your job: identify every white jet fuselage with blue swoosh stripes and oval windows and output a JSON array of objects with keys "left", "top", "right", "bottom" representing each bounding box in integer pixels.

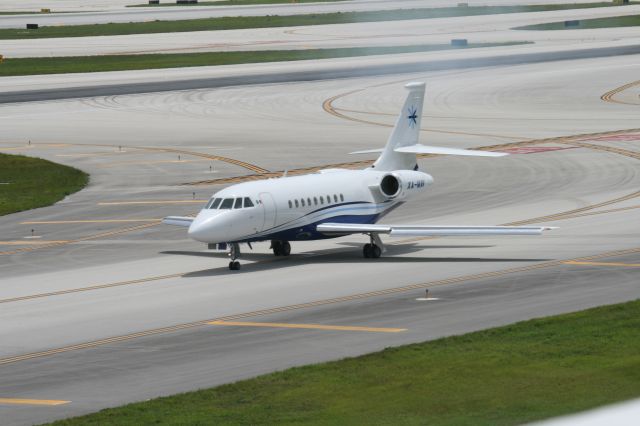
[{"left": 189, "top": 169, "right": 433, "bottom": 244}]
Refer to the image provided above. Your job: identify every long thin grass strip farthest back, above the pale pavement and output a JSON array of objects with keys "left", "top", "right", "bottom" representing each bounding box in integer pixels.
[{"left": 0, "top": 3, "right": 632, "bottom": 40}]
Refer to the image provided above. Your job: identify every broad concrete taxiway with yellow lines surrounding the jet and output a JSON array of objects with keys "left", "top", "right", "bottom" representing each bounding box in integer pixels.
[{"left": 0, "top": 34, "right": 640, "bottom": 424}]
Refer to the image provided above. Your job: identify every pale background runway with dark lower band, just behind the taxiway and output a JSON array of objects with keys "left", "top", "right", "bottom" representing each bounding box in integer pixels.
[{"left": 0, "top": 40, "right": 640, "bottom": 104}]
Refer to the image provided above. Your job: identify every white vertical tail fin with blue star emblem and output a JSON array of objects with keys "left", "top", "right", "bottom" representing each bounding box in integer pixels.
[{"left": 373, "top": 82, "right": 425, "bottom": 170}]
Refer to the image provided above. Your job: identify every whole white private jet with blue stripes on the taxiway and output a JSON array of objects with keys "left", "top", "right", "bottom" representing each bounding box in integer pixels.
[{"left": 163, "top": 83, "right": 551, "bottom": 270}]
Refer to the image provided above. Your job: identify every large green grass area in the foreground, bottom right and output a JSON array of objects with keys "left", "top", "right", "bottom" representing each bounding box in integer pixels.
[{"left": 48, "top": 301, "right": 640, "bottom": 426}]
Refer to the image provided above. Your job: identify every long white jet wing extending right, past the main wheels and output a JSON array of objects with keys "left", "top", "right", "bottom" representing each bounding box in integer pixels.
[{"left": 316, "top": 223, "right": 554, "bottom": 237}]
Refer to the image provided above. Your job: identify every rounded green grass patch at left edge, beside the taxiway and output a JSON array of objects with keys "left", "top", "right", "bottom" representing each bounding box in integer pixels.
[{"left": 0, "top": 154, "right": 89, "bottom": 215}]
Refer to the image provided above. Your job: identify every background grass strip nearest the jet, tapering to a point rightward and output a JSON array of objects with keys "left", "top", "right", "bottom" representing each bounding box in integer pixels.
[{"left": 0, "top": 43, "right": 522, "bottom": 77}]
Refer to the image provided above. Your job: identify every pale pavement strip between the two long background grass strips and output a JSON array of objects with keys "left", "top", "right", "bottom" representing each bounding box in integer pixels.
[{"left": 0, "top": 5, "right": 640, "bottom": 58}]
